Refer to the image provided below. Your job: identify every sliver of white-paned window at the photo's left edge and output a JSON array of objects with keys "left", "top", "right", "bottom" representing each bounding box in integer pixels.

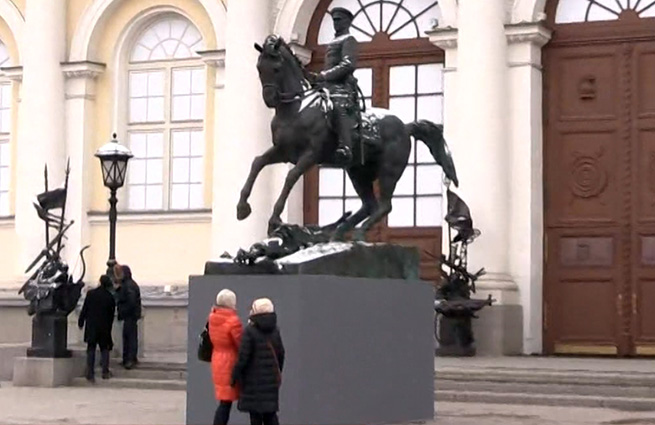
[{"left": 0, "top": 41, "right": 11, "bottom": 216}]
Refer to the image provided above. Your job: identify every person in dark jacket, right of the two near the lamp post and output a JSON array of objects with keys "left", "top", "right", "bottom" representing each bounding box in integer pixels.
[{"left": 114, "top": 264, "right": 141, "bottom": 369}]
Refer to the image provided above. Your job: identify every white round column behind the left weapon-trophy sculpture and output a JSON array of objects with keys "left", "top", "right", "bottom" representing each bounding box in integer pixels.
[{"left": 16, "top": 0, "right": 66, "bottom": 273}]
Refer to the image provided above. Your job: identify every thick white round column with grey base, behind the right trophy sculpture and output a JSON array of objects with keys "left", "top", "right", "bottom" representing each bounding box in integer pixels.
[{"left": 446, "top": 0, "right": 523, "bottom": 355}]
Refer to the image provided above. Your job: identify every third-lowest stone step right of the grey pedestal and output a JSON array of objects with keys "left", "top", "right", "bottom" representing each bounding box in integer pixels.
[{"left": 435, "top": 368, "right": 655, "bottom": 387}]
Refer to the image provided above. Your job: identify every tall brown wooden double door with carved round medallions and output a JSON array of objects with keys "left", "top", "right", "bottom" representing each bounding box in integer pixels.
[{"left": 544, "top": 32, "right": 655, "bottom": 356}]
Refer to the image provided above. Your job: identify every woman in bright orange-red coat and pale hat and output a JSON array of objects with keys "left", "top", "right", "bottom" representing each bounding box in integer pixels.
[{"left": 208, "top": 289, "right": 243, "bottom": 425}]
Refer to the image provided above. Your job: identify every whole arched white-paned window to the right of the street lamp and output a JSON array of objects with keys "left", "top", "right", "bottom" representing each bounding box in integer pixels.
[{"left": 127, "top": 15, "right": 206, "bottom": 210}]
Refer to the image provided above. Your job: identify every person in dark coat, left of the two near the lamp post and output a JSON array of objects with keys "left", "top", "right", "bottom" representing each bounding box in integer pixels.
[{"left": 77, "top": 275, "right": 116, "bottom": 382}]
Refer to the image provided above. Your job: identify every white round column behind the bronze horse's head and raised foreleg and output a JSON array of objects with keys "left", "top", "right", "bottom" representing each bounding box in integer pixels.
[{"left": 212, "top": 0, "right": 276, "bottom": 255}]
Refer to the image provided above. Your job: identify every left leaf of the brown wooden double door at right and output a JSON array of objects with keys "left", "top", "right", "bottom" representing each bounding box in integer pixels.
[{"left": 544, "top": 45, "right": 627, "bottom": 355}]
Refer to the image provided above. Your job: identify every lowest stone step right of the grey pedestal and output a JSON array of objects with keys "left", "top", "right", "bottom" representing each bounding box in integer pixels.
[{"left": 435, "top": 390, "right": 655, "bottom": 412}]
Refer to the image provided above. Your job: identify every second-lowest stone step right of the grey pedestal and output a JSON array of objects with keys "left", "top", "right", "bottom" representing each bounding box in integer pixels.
[{"left": 435, "top": 379, "right": 655, "bottom": 403}]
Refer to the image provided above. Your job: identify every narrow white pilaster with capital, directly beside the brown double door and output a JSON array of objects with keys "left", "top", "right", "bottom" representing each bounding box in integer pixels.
[{"left": 506, "top": 23, "right": 550, "bottom": 354}]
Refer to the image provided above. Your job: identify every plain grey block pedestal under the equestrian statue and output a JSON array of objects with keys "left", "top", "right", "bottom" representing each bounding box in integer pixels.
[{"left": 187, "top": 274, "right": 434, "bottom": 425}]
